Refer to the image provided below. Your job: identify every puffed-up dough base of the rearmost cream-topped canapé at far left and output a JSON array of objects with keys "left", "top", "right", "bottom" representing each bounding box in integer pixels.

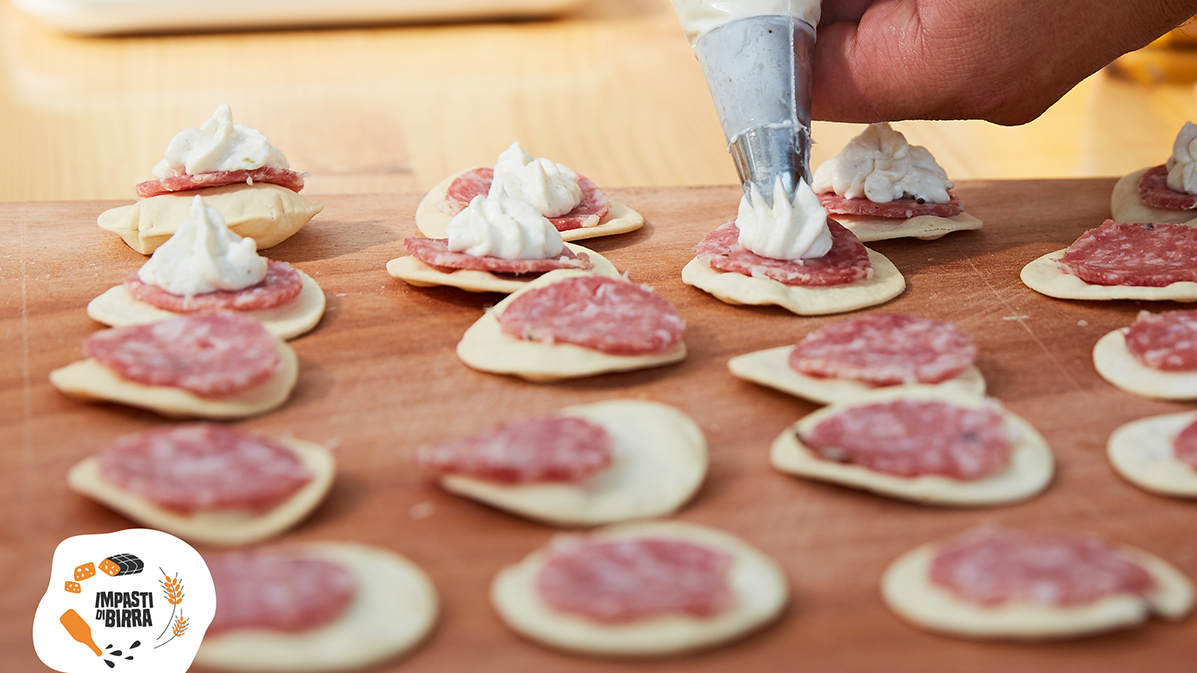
[{"left": 96, "top": 182, "right": 324, "bottom": 255}]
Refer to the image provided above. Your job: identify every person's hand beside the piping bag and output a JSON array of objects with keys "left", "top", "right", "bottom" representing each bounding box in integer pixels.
[{"left": 812, "top": 0, "right": 1197, "bottom": 125}]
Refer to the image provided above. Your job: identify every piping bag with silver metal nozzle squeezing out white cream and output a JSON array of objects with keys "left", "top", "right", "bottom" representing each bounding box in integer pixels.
[{"left": 673, "top": 0, "right": 819, "bottom": 206}]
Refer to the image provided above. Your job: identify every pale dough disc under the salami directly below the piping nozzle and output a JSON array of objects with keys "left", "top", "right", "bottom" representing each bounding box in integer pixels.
[{"left": 681, "top": 250, "right": 906, "bottom": 315}]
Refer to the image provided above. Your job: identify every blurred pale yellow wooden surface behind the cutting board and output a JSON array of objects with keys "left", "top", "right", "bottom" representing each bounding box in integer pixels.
[{"left": 7, "top": 0, "right": 1197, "bottom": 201}]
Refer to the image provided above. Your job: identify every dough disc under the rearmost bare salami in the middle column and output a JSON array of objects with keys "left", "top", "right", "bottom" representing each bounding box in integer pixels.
[{"left": 457, "top": 269, "right": 686, "bottom": 381}]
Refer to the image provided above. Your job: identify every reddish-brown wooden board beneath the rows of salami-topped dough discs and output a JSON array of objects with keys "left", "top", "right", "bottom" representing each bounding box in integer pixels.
[{"left": 0, "top": 180, "right": 1197, "bottom": 673}]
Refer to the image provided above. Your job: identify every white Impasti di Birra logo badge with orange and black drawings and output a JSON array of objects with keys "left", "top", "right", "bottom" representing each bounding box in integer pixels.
[{"left": 34, "top": 529, "right": 217, "bottom": 673}]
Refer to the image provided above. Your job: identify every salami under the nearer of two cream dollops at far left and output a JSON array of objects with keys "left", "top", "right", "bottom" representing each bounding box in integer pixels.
[{"left": 124, "top": 260, "right": 303, "bottom": 313}]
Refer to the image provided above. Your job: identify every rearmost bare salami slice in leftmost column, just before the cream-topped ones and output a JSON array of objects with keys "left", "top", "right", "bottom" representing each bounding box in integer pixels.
[{"left": 83, "top": 313, "right": 280, "bottom": 398}]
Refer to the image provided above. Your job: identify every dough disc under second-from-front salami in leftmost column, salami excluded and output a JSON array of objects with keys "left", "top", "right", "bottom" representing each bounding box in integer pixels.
[{"left": 67, "top": 438, "right": 336, "bottom": 545}]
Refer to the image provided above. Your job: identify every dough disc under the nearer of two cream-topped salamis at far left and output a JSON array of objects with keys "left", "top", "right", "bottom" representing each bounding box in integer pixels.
[{"left": 87, "top": 269, "right": 324, "bottom": 339}]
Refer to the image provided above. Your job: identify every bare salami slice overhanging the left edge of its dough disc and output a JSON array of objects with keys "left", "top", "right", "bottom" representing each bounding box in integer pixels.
[{"left": 415, "top": 416, "right": 610, "bottom": 483}]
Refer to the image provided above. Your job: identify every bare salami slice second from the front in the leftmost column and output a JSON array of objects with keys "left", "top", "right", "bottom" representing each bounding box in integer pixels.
[{"left": 97, "top": 423, "right": 312, "bottom": 514}]
